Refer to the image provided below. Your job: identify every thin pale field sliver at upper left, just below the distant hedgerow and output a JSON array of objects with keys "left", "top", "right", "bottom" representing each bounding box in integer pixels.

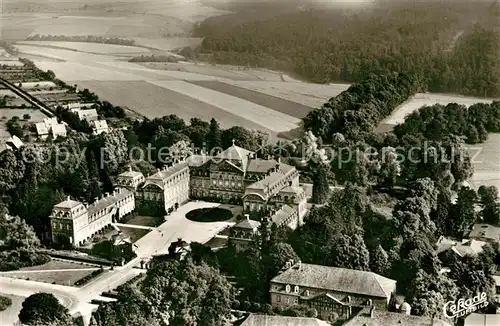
[{"left": 16, "top": 41, "right": 151, "bottom": 56}]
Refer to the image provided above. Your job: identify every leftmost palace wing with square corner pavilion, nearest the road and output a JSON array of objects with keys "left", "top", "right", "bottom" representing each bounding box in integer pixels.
[{"left": 50, "top": 188, "right": 135, "bottom": 247}]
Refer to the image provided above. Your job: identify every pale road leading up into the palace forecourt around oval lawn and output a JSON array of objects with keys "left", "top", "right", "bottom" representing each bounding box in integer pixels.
[{"left": 0, "top": 202, "right": 234, "bottom": 324}]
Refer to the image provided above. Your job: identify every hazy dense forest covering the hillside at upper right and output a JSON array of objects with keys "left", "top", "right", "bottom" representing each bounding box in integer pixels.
[{"left": 194, "top": 1, "right": 500, "bottom": 96}]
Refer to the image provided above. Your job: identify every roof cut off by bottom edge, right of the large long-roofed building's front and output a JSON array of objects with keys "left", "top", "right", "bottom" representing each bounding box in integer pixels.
[{"left": 344, "top": 308, "right": 451, "bottom": 326}]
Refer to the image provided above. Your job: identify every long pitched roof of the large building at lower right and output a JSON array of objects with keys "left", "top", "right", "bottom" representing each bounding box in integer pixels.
[{"left": 271, "top": 263, "right": 396, "bottom": 298}]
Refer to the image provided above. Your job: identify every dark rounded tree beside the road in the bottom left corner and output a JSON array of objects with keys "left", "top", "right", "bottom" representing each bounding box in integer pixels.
[{"left": 19, "top": 292, "right": 73, "bottom": 326}]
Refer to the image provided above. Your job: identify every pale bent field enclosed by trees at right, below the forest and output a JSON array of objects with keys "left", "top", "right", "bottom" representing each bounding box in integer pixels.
[{"left": 382, "top": 93, "right": 495, "bottom": 125}]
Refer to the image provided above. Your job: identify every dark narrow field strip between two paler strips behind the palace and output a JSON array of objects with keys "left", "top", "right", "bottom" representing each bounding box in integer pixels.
[{"left": 191, "top": 81, "right": 312, "bottom": 119}]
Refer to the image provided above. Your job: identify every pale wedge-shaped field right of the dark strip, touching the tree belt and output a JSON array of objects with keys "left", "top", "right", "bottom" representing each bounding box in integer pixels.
[{"left": 227, "top": 81, "right": 350, "bottom": 108}]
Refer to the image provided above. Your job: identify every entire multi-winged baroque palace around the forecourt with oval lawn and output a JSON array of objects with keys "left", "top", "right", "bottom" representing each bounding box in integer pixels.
[{"left": 51, "top": 141, "right": 307, "bottom": 246}]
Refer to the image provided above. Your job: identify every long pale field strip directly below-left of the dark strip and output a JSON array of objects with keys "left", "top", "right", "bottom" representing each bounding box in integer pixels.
[{"left": 150, "top": 80, "right": 300, "bottom": 132}]
